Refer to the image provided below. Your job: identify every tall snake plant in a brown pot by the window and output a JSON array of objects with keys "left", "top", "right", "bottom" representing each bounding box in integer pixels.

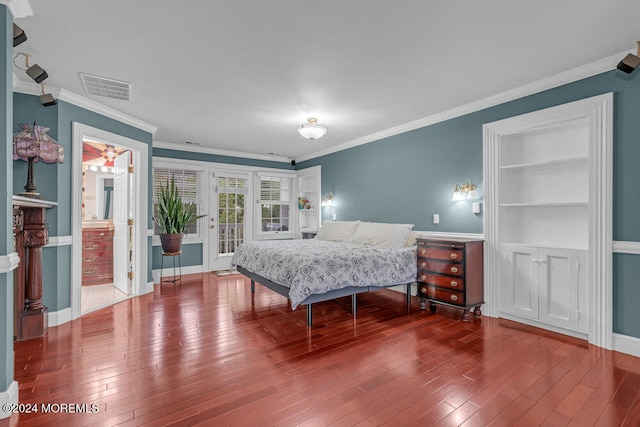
[{"left": 153, "top": 177, "right": 205, "bottom": 254}]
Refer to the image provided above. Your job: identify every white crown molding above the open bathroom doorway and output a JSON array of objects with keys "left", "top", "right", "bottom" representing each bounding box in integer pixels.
[{"left": 13, "top": 78, "right": 158, "bottom": 135}]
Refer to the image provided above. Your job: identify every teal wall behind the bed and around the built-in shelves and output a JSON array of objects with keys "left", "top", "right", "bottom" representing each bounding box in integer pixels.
[{"left": 297, "top": 70, "right": 640, "bottom": 338}]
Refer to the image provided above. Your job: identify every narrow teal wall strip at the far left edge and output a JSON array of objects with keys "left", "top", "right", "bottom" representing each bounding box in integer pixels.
[{"left": 0, "top": 4, "right": 13, "bottom": 398}]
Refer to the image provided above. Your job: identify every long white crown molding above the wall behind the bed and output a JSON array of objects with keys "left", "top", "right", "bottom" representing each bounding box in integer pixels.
[{"left": 296, "top": 50, "right": 635, "bottom": 163}]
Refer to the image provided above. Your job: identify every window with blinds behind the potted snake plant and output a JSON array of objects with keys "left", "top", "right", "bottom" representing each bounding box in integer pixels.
[{"left": 153, "top": 168, "right": 203, "bottom": 236}]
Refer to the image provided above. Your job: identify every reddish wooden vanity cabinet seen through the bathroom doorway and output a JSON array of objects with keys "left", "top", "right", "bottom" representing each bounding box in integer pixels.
[{"left": 82, "top": 227, "right": 113, "bottom": 286}]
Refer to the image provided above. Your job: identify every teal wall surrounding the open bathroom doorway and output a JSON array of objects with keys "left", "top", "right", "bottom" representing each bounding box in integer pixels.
[{"left": 12, "top": 93, "right": 152, "bottom": 312}]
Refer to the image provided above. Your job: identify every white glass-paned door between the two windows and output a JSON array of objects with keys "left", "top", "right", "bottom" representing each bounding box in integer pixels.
[{"left": 207, "top": 171, "right": 251, "bottom": 270}]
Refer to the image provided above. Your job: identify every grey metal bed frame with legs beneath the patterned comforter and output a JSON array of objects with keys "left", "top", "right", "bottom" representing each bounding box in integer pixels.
[{"left": 236, "top": 265, "right": 414, "bottom": 327}]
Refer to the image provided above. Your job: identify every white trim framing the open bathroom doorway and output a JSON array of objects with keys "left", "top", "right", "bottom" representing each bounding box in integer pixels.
[{"left": 71, "top": 122, "right": 149, "bottom": 319}]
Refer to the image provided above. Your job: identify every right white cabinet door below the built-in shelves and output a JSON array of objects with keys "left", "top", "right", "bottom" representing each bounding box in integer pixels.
[{"left": 536, "top": 249, "right": 579, "bottom": 331}]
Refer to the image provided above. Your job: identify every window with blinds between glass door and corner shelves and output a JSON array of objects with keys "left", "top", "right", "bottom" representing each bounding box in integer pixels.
[{"left": 258, "top": 175, "right": 292, "bottom": 234}]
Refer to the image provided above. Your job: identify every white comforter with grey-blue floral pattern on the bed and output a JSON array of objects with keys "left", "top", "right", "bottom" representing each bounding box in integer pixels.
[{"left": 232, "top": 239, "right": 416, "bottom": 309}]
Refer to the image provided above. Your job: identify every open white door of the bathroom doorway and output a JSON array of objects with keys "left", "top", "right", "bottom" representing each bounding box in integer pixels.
[{"left": 113, "top": 151, "right": 133, "bottom": 294}]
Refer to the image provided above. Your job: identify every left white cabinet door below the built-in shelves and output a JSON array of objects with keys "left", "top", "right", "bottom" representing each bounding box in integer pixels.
[{"left": 502, "top": 246, "right": 538, "bottom": 319}]
